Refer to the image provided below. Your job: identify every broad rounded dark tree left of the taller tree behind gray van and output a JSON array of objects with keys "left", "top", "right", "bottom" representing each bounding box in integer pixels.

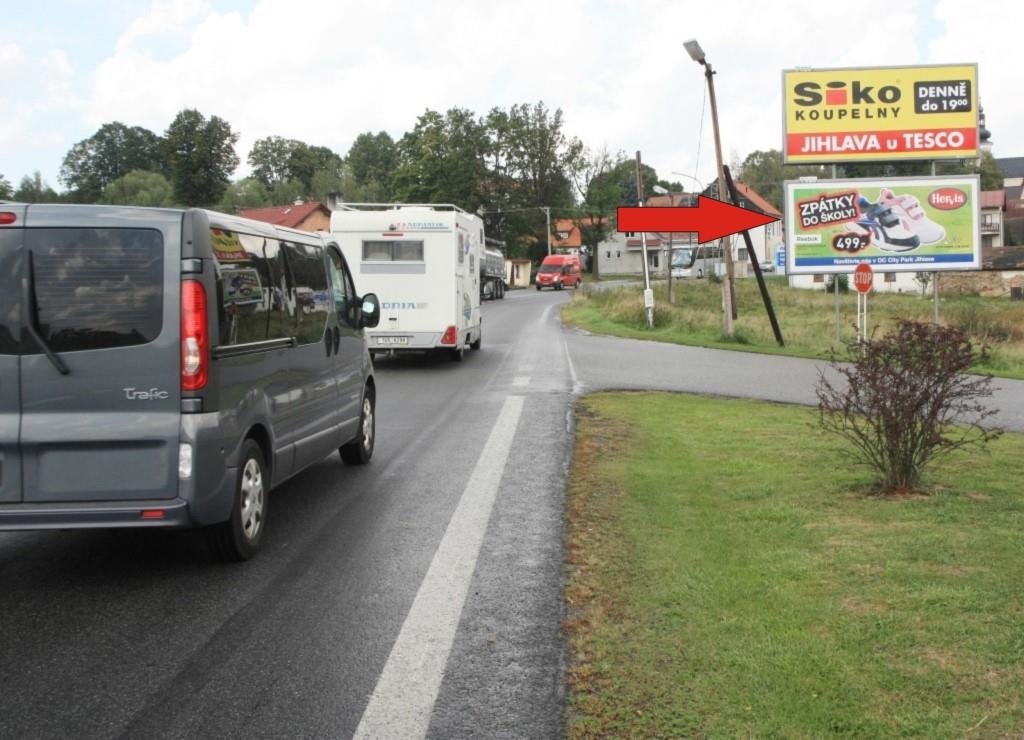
[{"left": 57, "top": 121, "right": 167, "bottom": 203}]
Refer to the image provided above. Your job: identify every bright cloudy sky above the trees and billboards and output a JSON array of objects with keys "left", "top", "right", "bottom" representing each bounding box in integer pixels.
[{"left": 0, "top": 0, "right": 1024, "bottom": 195}]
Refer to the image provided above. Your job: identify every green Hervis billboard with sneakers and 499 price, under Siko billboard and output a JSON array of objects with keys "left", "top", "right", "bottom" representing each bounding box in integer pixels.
[{"left": 785, "top": 175, "right": 981, "bottom": 274}]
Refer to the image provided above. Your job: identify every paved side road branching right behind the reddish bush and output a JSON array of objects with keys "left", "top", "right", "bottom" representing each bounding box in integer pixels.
[{"left": 565, "top": 330, "right": 1024, "bottom": 432}]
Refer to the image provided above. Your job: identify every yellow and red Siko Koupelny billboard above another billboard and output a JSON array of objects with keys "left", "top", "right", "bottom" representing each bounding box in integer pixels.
[{"left": 782, "top": 64, "right": 978, "bottom": 164}]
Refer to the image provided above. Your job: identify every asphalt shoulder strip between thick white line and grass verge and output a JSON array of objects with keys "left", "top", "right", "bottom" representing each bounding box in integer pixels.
[{"left": 428, "top": 291, "right": 573, "bottom": 739}]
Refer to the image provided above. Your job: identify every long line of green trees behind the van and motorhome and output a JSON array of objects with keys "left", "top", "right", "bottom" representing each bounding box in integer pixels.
[{"left": 0, "top": 101, "right": 680, "bottom": 257}]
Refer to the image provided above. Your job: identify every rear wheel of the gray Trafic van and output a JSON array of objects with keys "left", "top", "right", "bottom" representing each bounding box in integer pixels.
[{"left": 206, "top": 439, "right": 270, "bottom": 562}]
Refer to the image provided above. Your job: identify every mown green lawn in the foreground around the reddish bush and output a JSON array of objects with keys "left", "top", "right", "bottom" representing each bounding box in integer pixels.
[{"left": 566, "top": 393, "right": 1024, "bottom": 738}]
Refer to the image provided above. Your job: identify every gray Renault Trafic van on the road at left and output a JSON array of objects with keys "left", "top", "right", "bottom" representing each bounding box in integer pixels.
[{"left": 0, "top": 203, "right": 380, "bottom": 560}]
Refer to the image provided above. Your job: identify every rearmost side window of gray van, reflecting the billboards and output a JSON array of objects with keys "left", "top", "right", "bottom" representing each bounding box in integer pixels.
[{"left": 210, "top": 227, "right": 294, "bottom": 347}]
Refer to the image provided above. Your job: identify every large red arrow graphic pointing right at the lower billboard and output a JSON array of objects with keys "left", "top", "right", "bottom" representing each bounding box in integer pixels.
[{"left": 617, "top": 195, "right": 778, "bottom": 244}]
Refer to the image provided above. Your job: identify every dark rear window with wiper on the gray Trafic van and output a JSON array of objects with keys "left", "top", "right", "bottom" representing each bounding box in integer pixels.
[{"left": 26, "top": 228, "right": 164, "bottom": 352}]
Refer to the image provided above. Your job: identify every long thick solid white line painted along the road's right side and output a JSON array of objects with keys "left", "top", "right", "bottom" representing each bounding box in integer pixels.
[{"left": 354, "top": 396, "right": 523, "bottom": 740}]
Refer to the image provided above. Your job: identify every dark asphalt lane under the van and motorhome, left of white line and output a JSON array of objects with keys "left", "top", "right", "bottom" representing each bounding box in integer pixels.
[{"left": 0, "top": 286, "right": 569, "bottom": 737}]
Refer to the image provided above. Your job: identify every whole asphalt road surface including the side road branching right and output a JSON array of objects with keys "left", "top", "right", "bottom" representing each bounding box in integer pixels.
[{"left": 0, "top": 284, "right": 1024, "bottom": 738}]
